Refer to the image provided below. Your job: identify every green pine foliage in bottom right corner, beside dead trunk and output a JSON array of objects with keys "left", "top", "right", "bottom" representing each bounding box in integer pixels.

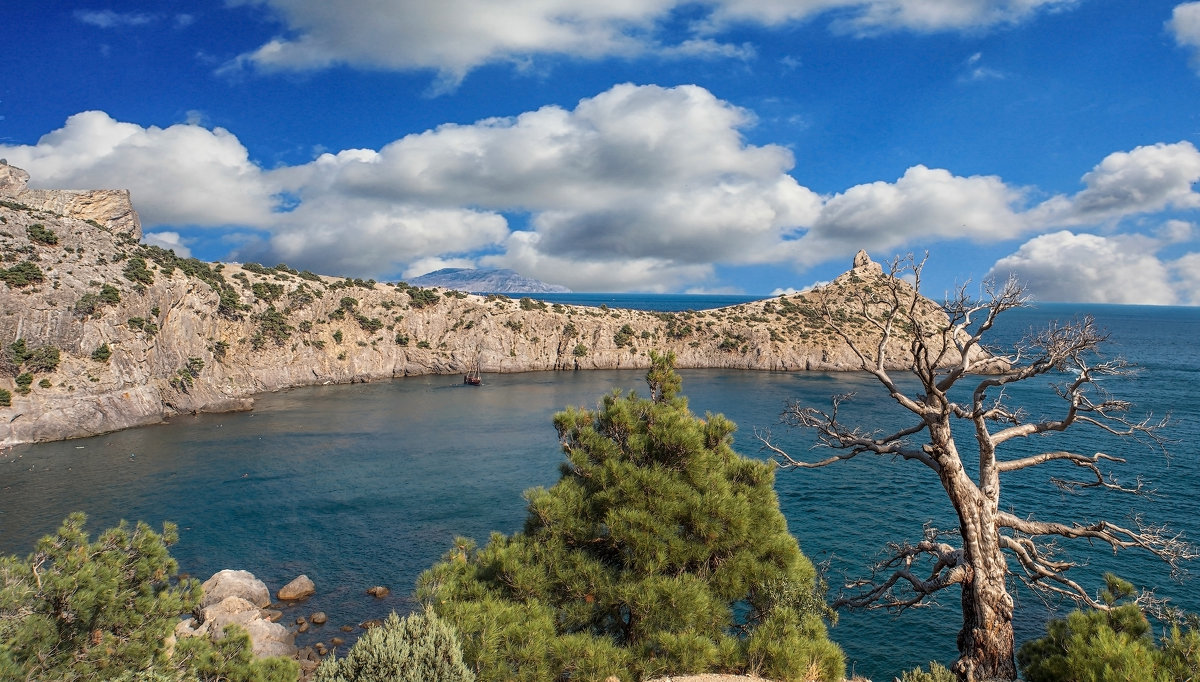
[{"left": 1016, "top": 575, "right": 1200, "bottom": 682}]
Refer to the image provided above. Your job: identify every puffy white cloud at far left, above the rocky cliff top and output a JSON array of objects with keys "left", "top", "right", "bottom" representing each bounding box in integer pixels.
[{"left": 0, "top": 112, "right": 274, "bottom": 226}]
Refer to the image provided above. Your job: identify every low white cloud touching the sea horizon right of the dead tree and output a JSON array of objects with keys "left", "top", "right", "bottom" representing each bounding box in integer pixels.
[{"left": 991, "top": 231, "right": 1176, "bottom": 305}]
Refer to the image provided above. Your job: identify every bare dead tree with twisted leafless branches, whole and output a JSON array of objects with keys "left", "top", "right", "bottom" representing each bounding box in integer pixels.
[{"left": 760, "top": 256, "right": 1195, "bottom": 681}]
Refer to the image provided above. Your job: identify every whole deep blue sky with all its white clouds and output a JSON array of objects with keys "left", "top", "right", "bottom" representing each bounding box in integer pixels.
[{"left": 0, "top": 0, "right": 1200, "bottom": 305}]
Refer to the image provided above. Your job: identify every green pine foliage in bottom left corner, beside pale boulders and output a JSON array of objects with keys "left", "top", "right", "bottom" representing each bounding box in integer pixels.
[{"left": 0, "top": 514, "right": 299, "bottom": 682}]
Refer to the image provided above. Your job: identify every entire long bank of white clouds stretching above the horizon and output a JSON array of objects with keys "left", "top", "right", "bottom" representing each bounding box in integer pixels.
[{"left": 9, "top": 84, "right": 1200, "bottom": 295}]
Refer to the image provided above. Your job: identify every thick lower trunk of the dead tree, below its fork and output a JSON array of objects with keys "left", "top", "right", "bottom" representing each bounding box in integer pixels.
[{"left": 953, "top": 492, "right": 1016, "bottom": 682}]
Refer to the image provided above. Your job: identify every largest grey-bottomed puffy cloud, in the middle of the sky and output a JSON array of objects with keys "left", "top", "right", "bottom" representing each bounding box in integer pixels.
[{"left": 272, "top": 84, "right": 821, "bottom": 283}]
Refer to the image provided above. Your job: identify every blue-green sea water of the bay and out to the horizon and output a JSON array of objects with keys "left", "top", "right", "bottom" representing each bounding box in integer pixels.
[{"left": 0, "top": 294, "right": 1200, "bottom": 681}]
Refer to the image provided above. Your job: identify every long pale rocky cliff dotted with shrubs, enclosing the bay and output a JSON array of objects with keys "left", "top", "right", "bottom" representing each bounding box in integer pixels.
[{"left": 0, "top": 164, "right": 988, "bottom": 445}]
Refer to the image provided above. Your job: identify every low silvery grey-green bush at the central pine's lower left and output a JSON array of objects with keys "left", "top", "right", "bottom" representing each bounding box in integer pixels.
[{"left": 313, "top": 610, "right": 475, "bottom": 682}]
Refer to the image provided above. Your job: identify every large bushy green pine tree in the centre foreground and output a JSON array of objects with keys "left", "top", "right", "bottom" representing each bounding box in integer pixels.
[{"left": 418, "top": 353, "right": 845, "bottom": 682}]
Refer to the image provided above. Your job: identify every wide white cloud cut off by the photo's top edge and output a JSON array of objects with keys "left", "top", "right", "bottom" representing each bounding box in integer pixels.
[{"left": 224, "top": 0, "right": 1078, "bottom": 88}]
